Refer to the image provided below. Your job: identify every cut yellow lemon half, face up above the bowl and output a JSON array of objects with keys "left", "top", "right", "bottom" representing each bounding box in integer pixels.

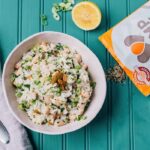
[{"left": 72, "top": 2, "right": 102, "bottom": 31}]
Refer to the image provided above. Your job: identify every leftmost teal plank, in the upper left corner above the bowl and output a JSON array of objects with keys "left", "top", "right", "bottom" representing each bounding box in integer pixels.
[{"left": 0, "top": 0, "right": 18, "bottom": 63}]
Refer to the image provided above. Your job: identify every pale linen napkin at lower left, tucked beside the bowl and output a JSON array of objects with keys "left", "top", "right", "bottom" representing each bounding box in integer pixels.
[{"left": 0, "top": 62, "right": 32, "bottom": 150}]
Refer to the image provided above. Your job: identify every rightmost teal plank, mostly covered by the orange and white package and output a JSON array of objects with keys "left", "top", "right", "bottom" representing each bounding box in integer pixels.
[{"left": 130, "top": 0, "right": 150, "bottom": 150}]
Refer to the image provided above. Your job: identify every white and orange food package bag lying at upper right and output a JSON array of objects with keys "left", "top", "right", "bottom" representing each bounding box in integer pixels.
[{"left": 99, "top": 1, "right": 150, "bottom": 96}]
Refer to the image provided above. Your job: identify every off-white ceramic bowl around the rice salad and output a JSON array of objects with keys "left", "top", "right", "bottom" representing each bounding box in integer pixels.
[{"left": 2, "top": 31, "right": 106, "bottom": 134}]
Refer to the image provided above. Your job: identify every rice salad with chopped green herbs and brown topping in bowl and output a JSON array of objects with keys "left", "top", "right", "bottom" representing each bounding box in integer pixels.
[{"left": 11, "top": 42, "right": 96, "bottom": 126}]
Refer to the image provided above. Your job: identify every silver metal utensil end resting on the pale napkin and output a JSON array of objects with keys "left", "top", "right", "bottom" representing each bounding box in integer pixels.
[{"left": 0, "top": 121, "right": 10, "bottom": 144}]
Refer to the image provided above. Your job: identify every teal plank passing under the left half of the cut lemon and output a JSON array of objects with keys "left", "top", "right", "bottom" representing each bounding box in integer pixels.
[{"left": 63, "top": 0, "right": 86, "bottom": 150}]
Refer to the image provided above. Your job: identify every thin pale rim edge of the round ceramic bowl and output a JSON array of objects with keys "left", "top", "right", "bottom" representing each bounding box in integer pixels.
[{"left": 2, "top": 31, "right": 107, "bottom": 135}]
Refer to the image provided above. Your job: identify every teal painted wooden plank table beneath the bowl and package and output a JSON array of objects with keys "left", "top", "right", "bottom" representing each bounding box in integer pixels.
[{"left": 0, "top": 0, "right": 150, "bottom": 150}]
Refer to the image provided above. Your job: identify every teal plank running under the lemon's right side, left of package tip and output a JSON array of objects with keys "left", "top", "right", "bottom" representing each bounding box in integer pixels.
[{"left": 86, "top": 0, "right": 109, "bottom": 150}]
